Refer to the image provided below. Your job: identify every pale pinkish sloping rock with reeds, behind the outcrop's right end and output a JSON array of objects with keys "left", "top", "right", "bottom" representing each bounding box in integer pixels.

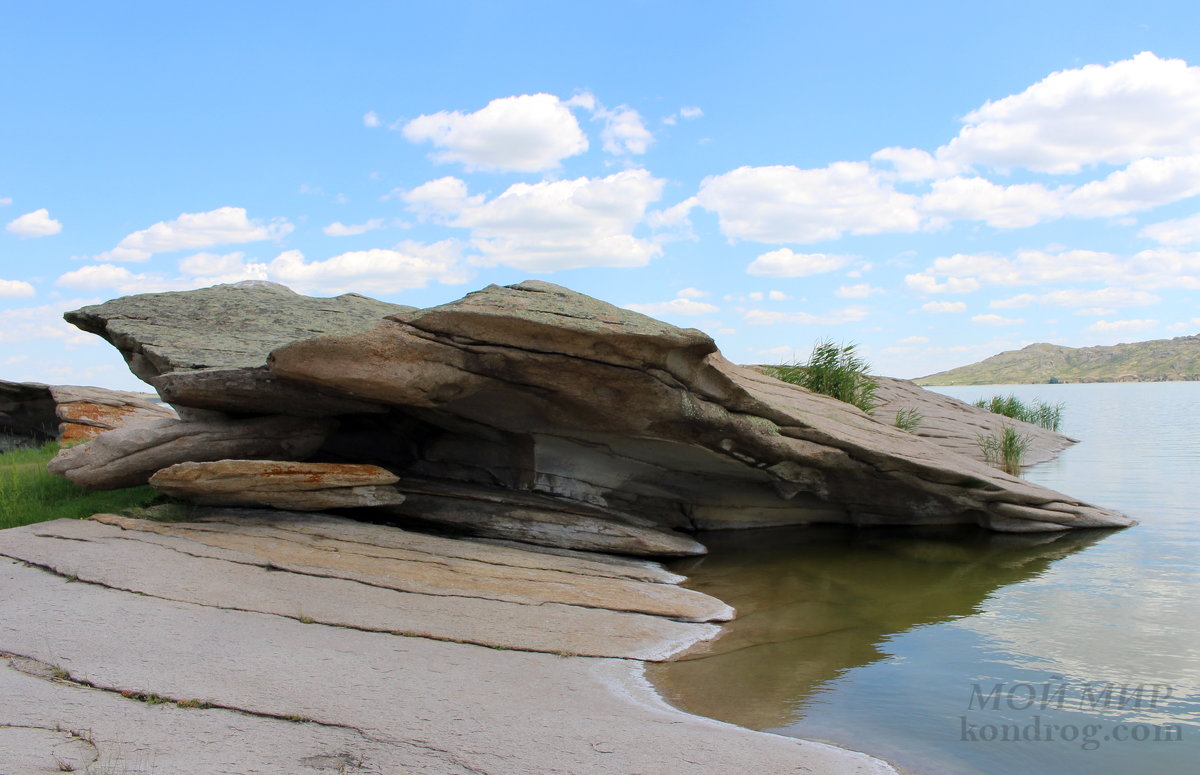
[{"left": 875, "top": 377, "right": 1075, "bottom": 465}]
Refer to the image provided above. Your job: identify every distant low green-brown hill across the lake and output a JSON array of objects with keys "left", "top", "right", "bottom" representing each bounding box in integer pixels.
[{"left": 913, "top": 335, "right": 1200, "bottom": 385}]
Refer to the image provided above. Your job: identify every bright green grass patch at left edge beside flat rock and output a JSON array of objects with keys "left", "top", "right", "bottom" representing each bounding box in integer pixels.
[{"left": 0, "top": 443, "right": 162, "bottom": 529}]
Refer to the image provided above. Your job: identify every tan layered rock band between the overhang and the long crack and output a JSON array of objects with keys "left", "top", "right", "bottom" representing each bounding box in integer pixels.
[{"left": 0, "top": 510, "right": 724, "bottom": 661}]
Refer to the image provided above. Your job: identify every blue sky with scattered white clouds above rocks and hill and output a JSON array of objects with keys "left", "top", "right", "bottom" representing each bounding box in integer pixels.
[{"left": 0, "top": 0, "right": 1200, "bottom": 389}]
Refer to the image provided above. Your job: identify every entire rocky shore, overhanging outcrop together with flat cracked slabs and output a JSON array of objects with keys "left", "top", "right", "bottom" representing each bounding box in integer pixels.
[{"left": 0, "top": 282, "right": 1132, "bottom": 775}]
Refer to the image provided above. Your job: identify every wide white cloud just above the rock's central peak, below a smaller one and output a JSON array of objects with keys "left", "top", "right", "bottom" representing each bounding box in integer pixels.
[{"left": 406, "top": 169, "right": 664, "bottom": 272}]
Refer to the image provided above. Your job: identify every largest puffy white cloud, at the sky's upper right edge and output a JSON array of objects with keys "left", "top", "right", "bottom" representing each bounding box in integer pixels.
[{"left": 937, "top": 52, "right": 1200, "bottom": 174}]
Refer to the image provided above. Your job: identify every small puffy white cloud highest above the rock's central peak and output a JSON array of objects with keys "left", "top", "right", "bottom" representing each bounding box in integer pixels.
[{"left": 403, "top": 94, "right": 588, "bottom": 173}]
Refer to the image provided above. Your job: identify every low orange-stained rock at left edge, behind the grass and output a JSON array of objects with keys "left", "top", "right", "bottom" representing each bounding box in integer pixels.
[{"left": 0, "top": 380, "right": 175, "bottom": 443}]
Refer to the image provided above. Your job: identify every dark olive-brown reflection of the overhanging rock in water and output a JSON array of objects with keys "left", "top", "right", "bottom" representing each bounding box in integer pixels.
[{"left": 647, "top": 527, "right": 1109, "bottom": 729}]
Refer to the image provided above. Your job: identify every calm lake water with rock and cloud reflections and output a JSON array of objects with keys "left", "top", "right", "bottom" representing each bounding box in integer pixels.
[{"left": 648, "top": 383, "right": 1200, "bottom": 775}]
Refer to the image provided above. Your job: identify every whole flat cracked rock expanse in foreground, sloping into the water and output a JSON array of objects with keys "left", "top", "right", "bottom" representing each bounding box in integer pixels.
[{"left": 0, "top": 523, "right": 893, "bottom": 775}]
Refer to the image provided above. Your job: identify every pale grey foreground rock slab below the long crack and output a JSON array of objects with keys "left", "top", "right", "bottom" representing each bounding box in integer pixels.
[{"left": 0, "top": 549, "right": 893, "bottom": 775}]
